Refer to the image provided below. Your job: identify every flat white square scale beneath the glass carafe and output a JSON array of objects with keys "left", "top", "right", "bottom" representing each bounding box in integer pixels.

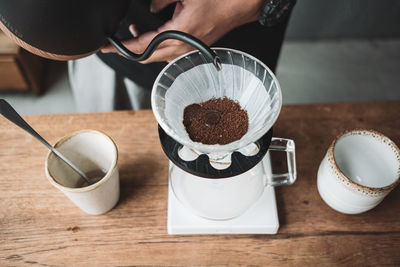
[{"left": 168, "top": 154, "right": 279, "bottom": 235}]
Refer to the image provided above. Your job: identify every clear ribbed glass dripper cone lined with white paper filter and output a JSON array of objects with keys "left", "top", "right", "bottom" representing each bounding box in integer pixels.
[{"left": 152, "top": 49, "right": 282, "bottom": 154}]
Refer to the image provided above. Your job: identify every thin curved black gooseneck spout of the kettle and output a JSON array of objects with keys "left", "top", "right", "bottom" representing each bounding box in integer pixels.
[{"left": 107, "top": 31, "right": 222, "bottom": 70}]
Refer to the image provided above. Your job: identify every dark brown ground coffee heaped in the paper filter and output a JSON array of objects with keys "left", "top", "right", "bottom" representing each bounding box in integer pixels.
[{"left": 183, "top": 97, "right": 249, "bottom": 145}]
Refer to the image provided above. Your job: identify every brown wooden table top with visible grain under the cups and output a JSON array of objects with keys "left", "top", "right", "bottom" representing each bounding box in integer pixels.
[{"left": 0, "top": 101, "right": 400, "bottom": 266}]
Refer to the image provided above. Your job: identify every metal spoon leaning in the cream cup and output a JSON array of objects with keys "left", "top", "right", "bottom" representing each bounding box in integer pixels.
[{"left": 0, "top": 99, "right": 101, "bottom": 185}]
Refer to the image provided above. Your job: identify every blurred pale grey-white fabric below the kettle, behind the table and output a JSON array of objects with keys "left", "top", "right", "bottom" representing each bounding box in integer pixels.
[{"left": 68, "top": 55, "right": 151, "bottom": 112}]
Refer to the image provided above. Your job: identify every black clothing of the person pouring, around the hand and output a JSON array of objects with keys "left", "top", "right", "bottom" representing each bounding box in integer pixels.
[{"left": 97, "top": 0, "right": 287, "bottom": 89}]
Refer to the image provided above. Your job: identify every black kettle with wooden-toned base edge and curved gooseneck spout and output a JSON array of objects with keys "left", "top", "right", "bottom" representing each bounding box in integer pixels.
[{"left": 0, "top": 0, "right": 220, "bottom": 69}]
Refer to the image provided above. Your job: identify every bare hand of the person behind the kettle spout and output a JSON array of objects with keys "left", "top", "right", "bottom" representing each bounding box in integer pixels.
[{"left": 101, "top": 0, "right": 263, "bottom": 63}]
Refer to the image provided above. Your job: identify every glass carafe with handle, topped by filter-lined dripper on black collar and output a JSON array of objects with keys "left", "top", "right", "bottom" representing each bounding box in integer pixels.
[{"left": 151, "top": 48, "right": 296, "bottom": 220}]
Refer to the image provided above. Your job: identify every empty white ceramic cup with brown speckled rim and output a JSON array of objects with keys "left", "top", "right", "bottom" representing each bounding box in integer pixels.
[{"left": 317, "top": 129, "right": 400, "bottom": 214}]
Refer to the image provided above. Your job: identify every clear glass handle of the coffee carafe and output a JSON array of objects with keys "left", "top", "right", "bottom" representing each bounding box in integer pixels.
[{"left": 265, "top": 137, "right": 297, "bottom": 186}]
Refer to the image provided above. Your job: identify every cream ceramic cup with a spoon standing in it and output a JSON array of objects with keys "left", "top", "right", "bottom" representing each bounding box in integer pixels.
[{"left": 45, "top": 130, "right": 119, "bottom": 215}]
